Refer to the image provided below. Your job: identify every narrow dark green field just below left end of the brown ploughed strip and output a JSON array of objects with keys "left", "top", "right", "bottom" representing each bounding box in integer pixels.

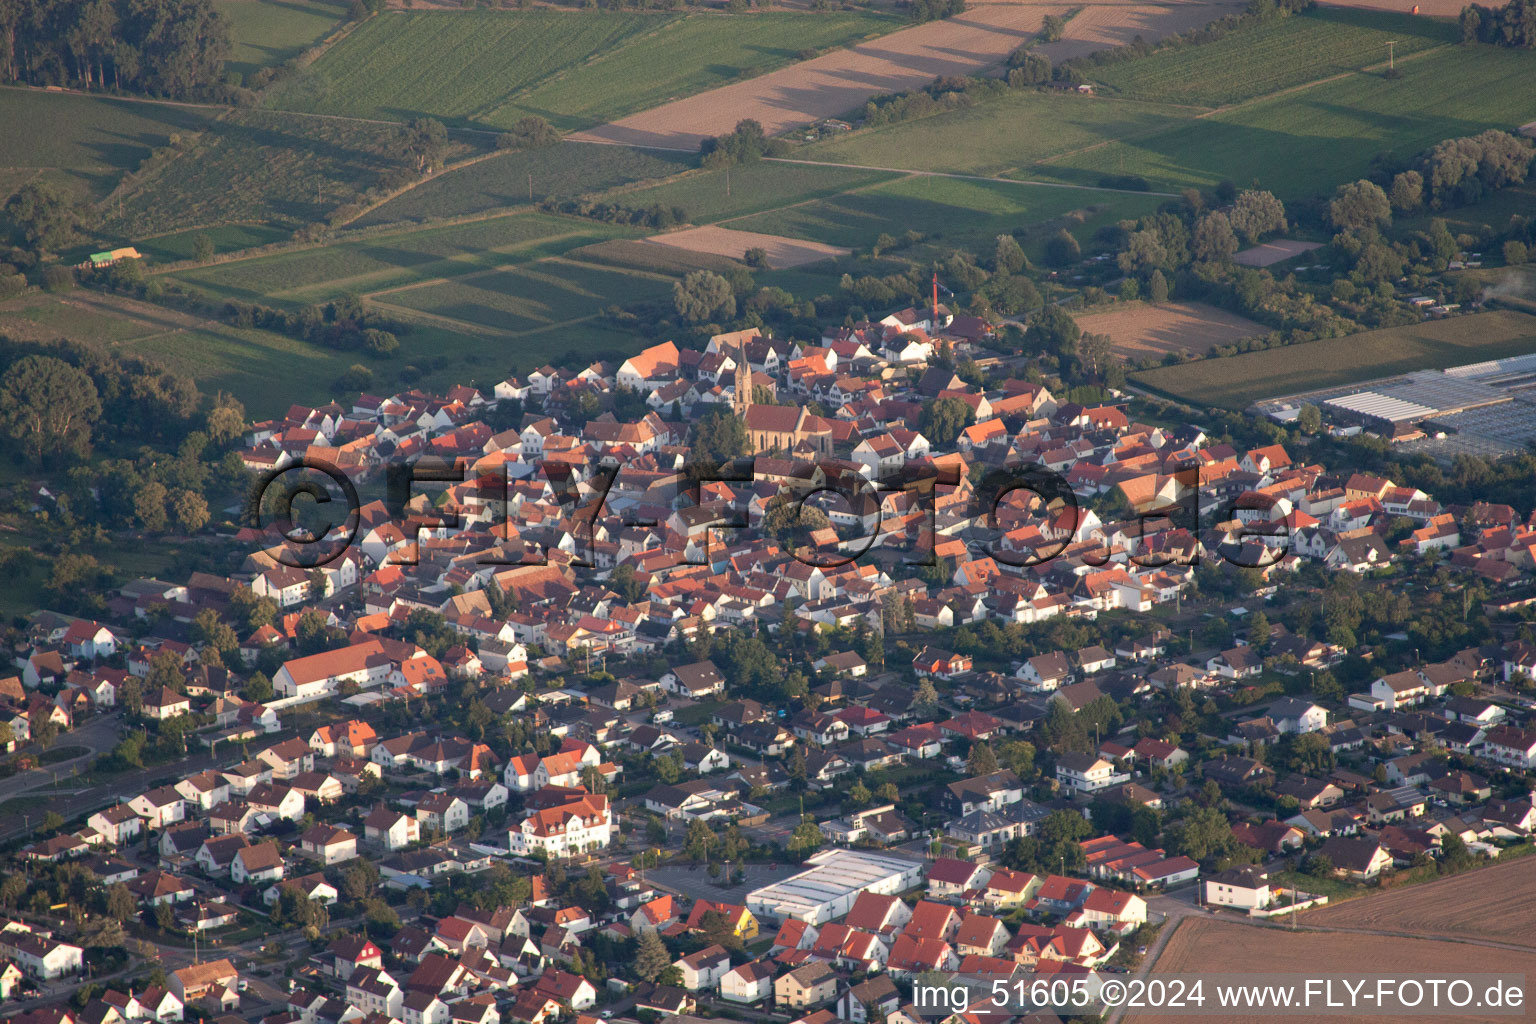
[{"left": 352, "top": 143, "right": 694, "bottom": 227}]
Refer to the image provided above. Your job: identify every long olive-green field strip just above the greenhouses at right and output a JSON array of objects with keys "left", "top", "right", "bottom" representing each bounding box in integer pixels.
[{"left": 1132, "top": 310, "right": 1536, "bottom": 410}]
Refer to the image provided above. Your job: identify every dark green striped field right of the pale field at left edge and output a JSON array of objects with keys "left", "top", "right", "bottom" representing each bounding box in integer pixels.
[{"left": 106, "top": 111, "right": 433, "bottom": 238}]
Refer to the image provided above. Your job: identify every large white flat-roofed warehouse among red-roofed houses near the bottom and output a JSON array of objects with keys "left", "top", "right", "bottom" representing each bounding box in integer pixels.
[{"left": 746, "top": 849, "right": 923, "bottom": 924}]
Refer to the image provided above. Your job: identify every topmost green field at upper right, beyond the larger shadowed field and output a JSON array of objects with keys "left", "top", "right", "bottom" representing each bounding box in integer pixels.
[{"left": 1089, "top": 8, "right": 1459, "bottom": 106}]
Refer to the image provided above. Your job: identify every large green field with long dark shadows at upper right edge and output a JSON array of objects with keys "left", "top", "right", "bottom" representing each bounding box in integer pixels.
[{"left": 1034, "top": 46, "right": 1536, "bottom": 198}]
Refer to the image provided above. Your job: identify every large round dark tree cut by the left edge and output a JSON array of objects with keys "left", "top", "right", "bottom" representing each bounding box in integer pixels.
[{"left": 0, "top": 356, "right": 101, "bottom": 464}]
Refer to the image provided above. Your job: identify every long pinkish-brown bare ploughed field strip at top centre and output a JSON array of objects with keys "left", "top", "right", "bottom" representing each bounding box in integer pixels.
[{"left": 571, "top": 0, "right": 1241, "bottom": 150}]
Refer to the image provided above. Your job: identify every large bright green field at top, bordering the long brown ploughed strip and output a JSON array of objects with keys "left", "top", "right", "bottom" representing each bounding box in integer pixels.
[{"left": 270, "top": 11, "right": 900, "bottom": 129}]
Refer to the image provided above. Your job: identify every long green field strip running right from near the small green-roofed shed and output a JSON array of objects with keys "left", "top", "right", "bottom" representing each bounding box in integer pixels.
[{"left": 160, "top": 212, "right": 605, "bottom": 307}]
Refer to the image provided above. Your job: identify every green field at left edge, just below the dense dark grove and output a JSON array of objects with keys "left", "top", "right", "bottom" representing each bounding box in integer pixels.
[{"left": 0, "top": 89, "right": 210, "bottom": 198}]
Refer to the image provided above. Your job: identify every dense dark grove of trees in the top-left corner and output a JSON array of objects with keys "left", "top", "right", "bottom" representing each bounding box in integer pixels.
[{"left": 0, "top": 0, "right": 230, "bottom": 100}]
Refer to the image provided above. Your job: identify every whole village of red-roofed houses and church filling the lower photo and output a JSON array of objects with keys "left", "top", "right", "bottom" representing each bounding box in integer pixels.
[{"left": 0, "top": 310, "right": 1536, "bottom": 1024}]
